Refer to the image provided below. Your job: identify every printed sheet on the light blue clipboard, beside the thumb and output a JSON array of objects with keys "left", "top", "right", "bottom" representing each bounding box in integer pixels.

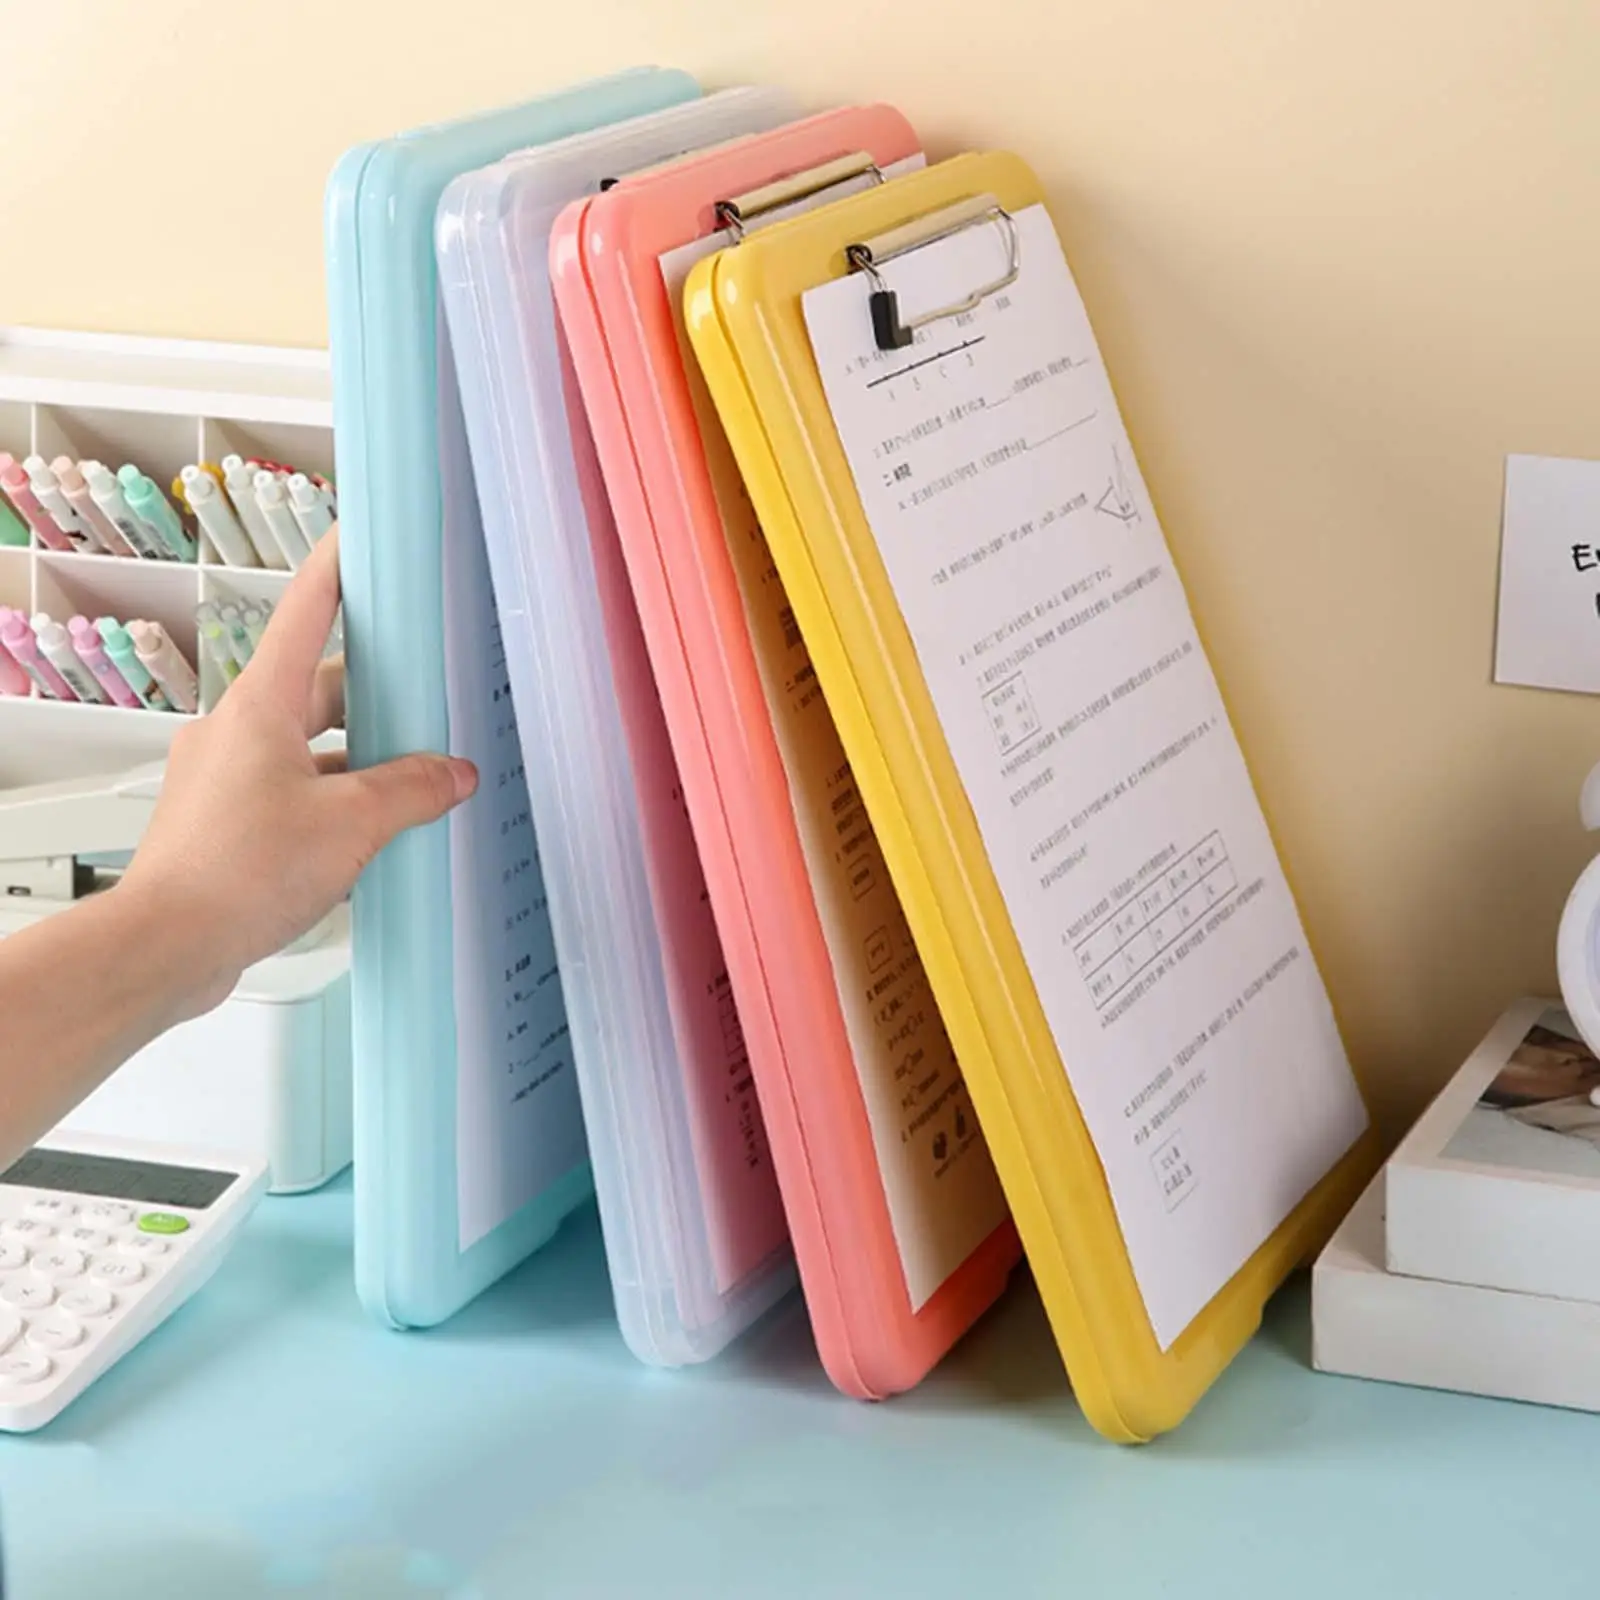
[{"left": 438, "top": 333, "right": 587, "bottom": 1251}]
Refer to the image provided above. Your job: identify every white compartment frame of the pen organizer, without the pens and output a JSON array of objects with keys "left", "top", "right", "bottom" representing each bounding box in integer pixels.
[{"left": 0, "top": 330, "right": 333, "bottom": 789}]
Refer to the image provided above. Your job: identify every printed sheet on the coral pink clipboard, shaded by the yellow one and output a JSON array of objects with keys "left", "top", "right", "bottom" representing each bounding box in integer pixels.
[{"left": 661, "top": 155, "right": 1006, "bottom": 1312}]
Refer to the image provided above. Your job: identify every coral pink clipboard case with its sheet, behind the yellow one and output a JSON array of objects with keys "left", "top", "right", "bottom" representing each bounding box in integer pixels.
[{"left": 550, "top": 106, "right": 1019, "bottom": 1398}]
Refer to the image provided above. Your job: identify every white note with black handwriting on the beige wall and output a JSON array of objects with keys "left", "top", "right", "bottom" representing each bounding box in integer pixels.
[{"left": 1494, "top": 456, "right": 1600, "bottom": 694}]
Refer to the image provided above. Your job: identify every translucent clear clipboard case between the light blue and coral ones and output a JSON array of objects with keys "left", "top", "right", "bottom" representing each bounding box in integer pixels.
[{"left": 437, "top": 88, "right": 795, "bottom": 1365}]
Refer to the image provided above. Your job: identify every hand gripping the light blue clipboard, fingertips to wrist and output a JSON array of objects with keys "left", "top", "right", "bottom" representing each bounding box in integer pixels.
[{"left": 114, "top": 528, "right": 478, "bottom": 1014}]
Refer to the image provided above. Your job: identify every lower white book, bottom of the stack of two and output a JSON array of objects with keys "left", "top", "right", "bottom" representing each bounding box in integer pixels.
[{"left": 1312, "top": 1174, "right": 1600, "bottom": 1411}]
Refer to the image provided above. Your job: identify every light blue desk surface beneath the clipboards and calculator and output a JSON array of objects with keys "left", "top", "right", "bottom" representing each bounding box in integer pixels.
[{"left": 0, "top": 1184, "right": 1600, "bottom": 1600}]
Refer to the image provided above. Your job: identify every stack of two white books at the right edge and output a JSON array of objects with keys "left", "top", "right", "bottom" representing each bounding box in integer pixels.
[{"left": 1312, "top": 1000, "right": 1600, "bottom": 1411}]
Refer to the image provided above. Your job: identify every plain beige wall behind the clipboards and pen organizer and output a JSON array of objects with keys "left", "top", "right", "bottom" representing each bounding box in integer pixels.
[{"left": 0, "top": 0, "right": 1600, "bottom": 1112}]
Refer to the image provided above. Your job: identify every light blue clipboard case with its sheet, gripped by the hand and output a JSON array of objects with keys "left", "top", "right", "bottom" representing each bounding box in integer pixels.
[{"left": 326, "top": 69, "right": 699, "bottom": 1326}]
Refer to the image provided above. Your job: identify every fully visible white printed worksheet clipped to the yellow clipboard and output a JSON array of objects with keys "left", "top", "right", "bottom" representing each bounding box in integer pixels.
[{"left": 803, "top": 206, "right": 1366, "bottom": 1350}]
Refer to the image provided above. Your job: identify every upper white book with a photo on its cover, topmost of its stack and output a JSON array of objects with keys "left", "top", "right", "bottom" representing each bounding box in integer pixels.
[{"left": 1379, "top": 1000, "right": 1600, "bottom": 1302}]
